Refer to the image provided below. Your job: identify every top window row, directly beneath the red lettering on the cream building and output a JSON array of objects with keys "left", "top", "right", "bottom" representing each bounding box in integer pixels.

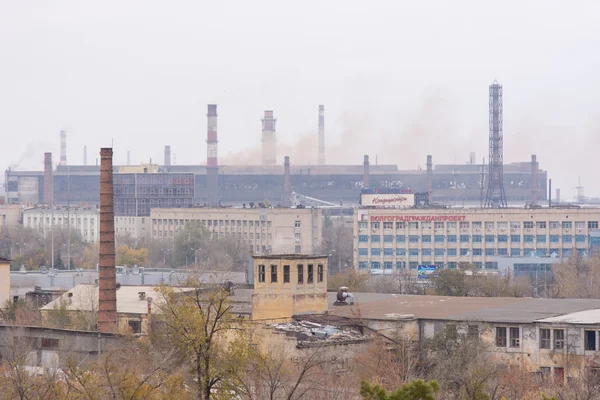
[{"left": 358, "top": 221, "right": 598, "bottom": 230}]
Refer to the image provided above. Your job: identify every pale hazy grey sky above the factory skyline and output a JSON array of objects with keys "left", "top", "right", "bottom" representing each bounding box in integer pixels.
[{"left": 0, "top": 0, "right": 600, "bottom": 198}]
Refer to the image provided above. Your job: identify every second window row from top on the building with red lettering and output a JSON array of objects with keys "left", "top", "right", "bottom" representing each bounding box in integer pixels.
[{"left": 358, "top": 235, "right": 587, "bottom": 243}]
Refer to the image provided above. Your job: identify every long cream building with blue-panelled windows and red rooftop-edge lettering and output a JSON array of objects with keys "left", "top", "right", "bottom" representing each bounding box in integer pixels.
[{"left": 354, "top": 207, "right": 600, "bottom": 273}]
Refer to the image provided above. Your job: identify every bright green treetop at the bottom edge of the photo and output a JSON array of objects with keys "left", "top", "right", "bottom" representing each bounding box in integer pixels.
[{"left": 360, "top": 379, "right": 440, "bottom": 400}]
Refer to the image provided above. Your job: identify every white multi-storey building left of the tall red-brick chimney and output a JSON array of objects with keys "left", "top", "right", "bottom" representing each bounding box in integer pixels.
[{"left": 23, "top": 206, "right": 100, "bottom": 243}]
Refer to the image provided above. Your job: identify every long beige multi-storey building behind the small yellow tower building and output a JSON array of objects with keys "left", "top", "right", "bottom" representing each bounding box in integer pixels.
[{"left": 150, "top": 207, "right": 322, "bottom": 254}]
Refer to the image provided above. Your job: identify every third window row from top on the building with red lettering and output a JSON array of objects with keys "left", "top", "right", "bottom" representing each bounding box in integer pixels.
[{"left": 358, "top": 247, "right": 587, "bottom": 257}]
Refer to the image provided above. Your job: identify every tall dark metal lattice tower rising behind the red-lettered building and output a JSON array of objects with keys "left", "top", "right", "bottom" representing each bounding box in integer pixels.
[{"left": 484, "top": 81, "right": 507, "bottom": 208}]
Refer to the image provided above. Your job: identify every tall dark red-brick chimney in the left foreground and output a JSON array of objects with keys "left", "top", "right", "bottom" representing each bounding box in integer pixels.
[{"left": 98, "top": 148, "right": 117, "bottom": 332}]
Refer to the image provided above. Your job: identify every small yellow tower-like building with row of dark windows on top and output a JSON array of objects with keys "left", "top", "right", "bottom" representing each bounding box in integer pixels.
[{"left": 252, "top": 254, "right": 328, "bottom": 321}]
